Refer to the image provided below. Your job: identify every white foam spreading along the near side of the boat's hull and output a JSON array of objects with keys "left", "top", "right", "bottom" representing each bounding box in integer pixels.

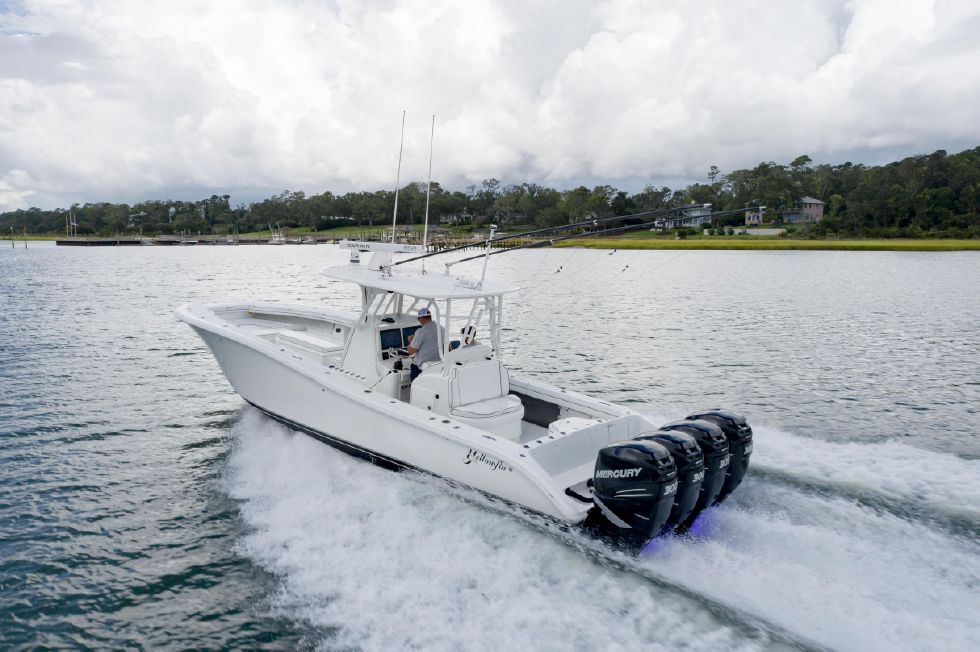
[{"left": 225, "top": 411, "right": 766, "bottom": 650}]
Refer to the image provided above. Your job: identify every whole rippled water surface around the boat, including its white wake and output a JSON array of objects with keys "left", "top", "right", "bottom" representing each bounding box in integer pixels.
[{"left": 0, "top": 244, "right": 980, "bottom": 650}]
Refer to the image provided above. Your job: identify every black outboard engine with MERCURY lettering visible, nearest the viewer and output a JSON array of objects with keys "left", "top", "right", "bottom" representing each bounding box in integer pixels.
[{"left": 592, "top": 440, "right": 677, "bottom": 543}]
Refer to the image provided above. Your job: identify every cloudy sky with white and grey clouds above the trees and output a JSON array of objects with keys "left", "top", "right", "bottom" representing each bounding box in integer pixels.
[{"left": 0, "top": 0, "right": 980, "bottom": 211}]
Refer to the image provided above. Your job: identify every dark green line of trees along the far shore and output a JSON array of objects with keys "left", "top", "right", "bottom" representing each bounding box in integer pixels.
[{"left": 0, "top": 147, "right": 980, "bottom": 237}]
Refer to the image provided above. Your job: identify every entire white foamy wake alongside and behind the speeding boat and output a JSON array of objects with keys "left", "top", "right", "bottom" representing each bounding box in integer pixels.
[{"left": 223, "top": 409, "right": 980, "bottom": 650}]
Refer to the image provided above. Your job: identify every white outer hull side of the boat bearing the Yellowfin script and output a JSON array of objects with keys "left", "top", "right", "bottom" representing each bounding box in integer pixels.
[{"left": 188, "top": 320, "right": 591, "bottom": 523}]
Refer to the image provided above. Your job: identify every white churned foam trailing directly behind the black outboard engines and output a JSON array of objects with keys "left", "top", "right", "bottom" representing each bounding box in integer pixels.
[{"left": 644, "top": 481, "right": 980, "bottom": 651}]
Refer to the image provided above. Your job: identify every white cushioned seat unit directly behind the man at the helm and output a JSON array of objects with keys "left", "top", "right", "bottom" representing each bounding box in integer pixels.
[{"left": 412, "top": 344, "right": 524, "bottom": 441}]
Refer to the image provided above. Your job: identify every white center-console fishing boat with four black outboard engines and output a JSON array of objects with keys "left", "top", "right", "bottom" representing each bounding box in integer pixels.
[{"left": 176, "top": 242, "right": 752, "bottom": 542}]
